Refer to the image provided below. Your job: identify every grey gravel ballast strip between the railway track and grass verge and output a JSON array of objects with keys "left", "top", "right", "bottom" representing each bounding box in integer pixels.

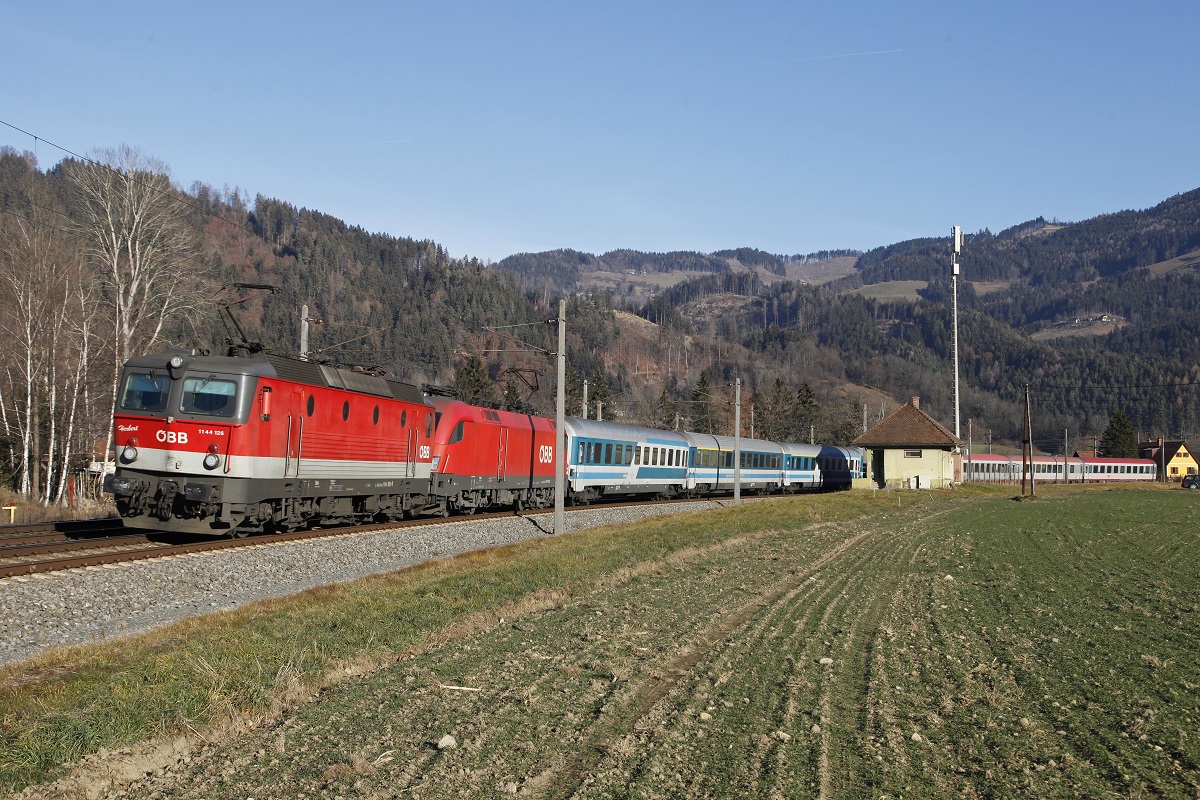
[{"left": 0, "top": 500, "right": 722, "bottom": 664}]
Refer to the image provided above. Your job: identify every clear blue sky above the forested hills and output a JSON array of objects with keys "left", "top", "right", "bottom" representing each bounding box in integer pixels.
[{"left": 0, "top": 0, "right": 1200, "bottom": 260}]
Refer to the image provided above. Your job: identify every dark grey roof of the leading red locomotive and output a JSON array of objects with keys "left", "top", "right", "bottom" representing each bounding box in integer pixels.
[{"left": 125, "top": 348, "right": 427, "bottom": 405}]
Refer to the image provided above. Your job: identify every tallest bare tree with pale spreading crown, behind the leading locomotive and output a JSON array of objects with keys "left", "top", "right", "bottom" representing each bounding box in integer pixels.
[{"left": 71, "top": 145, "right": 211, "bottom": 465}]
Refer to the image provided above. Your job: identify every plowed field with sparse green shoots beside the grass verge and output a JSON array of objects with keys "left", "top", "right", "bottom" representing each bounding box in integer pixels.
[{"left": 11, "top": 491, "right": 1200, "bottom": 800}]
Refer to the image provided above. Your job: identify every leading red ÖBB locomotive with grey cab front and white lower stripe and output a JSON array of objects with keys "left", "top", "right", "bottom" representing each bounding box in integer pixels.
[{"left": 104, "top": 348, "right": 434, "bottom": 536}]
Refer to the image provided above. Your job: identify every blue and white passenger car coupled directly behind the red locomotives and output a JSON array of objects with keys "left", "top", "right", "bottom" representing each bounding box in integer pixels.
[{"left": 564, "top": 417, "right": 690, "bottom": 503}]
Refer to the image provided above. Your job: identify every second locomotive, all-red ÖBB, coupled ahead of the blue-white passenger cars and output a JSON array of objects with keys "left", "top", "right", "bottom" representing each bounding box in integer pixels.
[{"left": 428, "top": 397, "right": 554, "bottom": 513}]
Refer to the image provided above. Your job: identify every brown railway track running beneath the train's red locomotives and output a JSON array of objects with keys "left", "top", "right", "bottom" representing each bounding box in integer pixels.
[{"left": 0, "top": 500, "right": 715, "bottom": 579}]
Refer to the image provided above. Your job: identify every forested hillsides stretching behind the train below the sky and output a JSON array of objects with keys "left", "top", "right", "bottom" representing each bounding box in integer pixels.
[{"left": 0, "top": 143, "right": 1200, "bottom": 501}]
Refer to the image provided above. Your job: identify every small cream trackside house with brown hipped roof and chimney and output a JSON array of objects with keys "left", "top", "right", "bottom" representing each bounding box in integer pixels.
[{"left": 852, "top": 397, "right": 964, "bottom": 489}]
